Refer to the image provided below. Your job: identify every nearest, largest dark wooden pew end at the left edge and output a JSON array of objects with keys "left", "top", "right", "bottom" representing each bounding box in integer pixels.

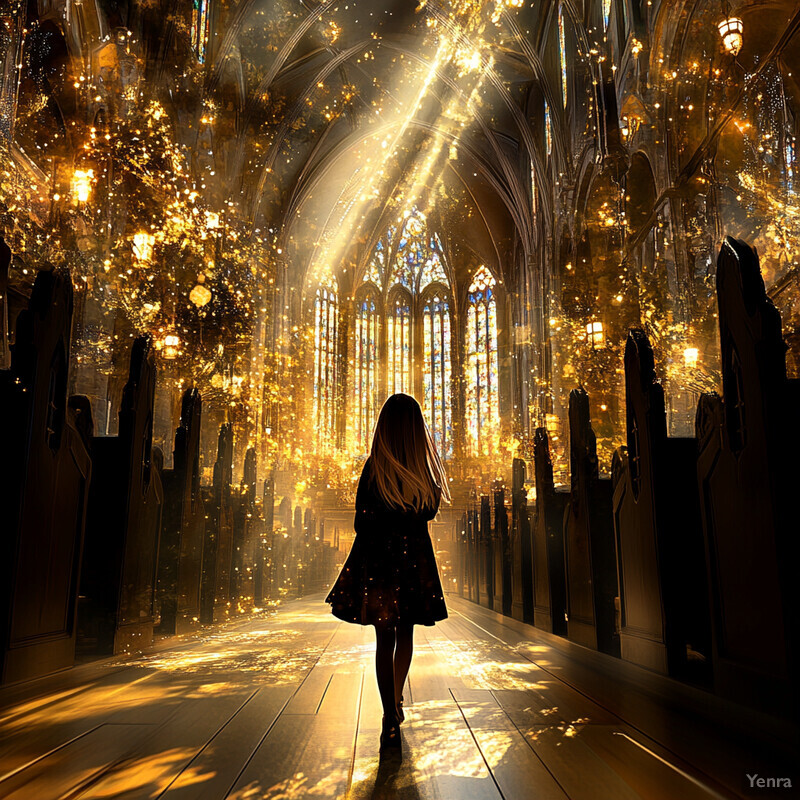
[{"left": 0, "top": 268, "right": 92, "bottom": 683}]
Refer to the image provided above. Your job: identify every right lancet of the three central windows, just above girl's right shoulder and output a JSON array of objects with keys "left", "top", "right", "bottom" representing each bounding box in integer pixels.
[{"left": 422, "top": 293, "right": 453, "bottom": 458}]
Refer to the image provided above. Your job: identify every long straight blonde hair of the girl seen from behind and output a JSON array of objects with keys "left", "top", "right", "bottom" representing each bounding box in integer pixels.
[{"left": 370, "top": 394, "right": 450, "bottom": 511}]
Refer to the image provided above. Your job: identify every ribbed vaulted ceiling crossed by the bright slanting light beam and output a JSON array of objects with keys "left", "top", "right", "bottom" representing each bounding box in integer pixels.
[{"left": 194, "top": 0, "right": 564, "bottom": 286}]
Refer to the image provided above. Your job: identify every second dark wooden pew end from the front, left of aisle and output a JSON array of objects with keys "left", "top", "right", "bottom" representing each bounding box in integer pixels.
[{"left": 79, "top": 336, "right": 164, "bottom": 654}]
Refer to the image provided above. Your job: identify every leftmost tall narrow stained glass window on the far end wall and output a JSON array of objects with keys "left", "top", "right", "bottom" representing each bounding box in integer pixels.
[{"left": 314, "top": 278, "right": 339, "bottom": 452}]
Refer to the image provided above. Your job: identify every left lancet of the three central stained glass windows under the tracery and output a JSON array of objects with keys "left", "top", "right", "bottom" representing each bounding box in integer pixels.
[{"left": 355, "top": 286, "right": 380, "bottom": 453}]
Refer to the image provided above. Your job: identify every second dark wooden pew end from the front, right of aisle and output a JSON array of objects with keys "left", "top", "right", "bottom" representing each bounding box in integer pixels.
[{"left": 612, "top": 329, "right": 711, "bottom": 684}]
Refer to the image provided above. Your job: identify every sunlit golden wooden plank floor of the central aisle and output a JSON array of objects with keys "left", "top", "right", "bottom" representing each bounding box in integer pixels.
[{"left": 0, "top": 595, "right": 791, "bottom": 800}]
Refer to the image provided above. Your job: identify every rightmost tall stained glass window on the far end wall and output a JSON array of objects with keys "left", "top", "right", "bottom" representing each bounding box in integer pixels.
[{"left": 465, "top": 267, "right": 500, "bottom": 456}]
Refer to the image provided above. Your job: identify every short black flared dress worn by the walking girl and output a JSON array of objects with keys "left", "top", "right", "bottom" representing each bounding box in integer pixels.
[{"left": 325, "top": 459, "right": 447, "bottom": 626}]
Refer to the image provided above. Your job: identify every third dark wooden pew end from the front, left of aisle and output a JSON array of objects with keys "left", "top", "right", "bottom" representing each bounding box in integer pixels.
[{"left": 158, "top": 389, "right": 205, "bottom": 635}]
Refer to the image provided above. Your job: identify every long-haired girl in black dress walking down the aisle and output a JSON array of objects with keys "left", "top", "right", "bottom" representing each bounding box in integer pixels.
[{"left": 326, "top": 394, "right": 450, "bottom": 748}]
